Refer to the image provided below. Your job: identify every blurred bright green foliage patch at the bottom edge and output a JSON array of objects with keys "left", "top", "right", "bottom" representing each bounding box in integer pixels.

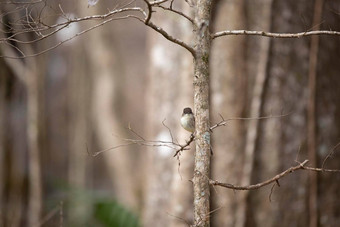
[{"left": 94, "top": 200, "right": 140, "bottom": 227}]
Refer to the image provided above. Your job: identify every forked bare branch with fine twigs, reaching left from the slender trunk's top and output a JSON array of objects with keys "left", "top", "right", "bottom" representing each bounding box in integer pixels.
[{"left": 0, "top": 0, "right": 195, "bottom": 58}]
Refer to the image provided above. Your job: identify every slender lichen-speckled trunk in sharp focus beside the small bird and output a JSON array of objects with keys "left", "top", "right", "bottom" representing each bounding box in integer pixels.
[{"left": 193, "top": 0, "right": 212, "bottom": 226}]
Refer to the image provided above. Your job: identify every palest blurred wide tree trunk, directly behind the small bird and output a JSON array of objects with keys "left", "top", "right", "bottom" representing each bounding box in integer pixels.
[{"left": 143, "top": 8, "right": 191, "bottom": 226}]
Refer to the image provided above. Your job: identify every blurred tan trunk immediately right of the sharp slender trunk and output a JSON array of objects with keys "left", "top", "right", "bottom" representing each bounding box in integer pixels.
[{"left": 211, "top": 0, "right": 248, "bottom": 226}]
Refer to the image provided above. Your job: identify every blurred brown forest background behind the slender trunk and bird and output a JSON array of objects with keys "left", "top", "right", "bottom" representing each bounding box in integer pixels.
[{"left": 0, "top": 0, "right": 340, "bottom": 226}]
